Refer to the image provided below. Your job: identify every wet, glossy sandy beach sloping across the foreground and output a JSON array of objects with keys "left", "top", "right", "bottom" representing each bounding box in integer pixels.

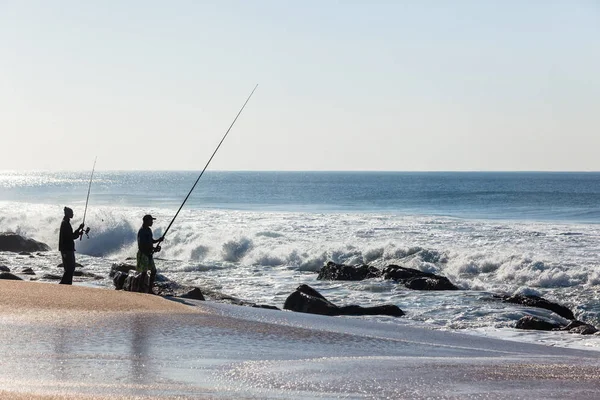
[{"left": 0, "top": 281, "right": 600, "bottom": 399}]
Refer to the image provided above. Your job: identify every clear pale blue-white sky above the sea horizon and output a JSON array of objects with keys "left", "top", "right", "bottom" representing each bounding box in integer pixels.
[{"left": 0, "top": 0, "right": 600, "bottom": 171}]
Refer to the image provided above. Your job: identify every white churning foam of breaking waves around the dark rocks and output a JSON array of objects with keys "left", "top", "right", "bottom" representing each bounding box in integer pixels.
[{"left": 0, "top": 202, "right": 600, "bottom": 346}]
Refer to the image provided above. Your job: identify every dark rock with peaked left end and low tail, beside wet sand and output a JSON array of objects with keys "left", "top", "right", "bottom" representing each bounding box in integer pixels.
[{"left": 283, "top": 285, "right": 404, "bottom": 317}]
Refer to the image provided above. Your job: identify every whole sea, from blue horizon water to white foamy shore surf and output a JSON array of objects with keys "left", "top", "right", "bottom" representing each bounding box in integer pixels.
[{"left": 0, "top": 171, "right": 600, "bottom": 350}]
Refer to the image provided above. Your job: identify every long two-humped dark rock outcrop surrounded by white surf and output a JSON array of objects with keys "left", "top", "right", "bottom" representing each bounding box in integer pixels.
[{"left": 317, "top": 261, "right": 458, "bottom": 290}]
